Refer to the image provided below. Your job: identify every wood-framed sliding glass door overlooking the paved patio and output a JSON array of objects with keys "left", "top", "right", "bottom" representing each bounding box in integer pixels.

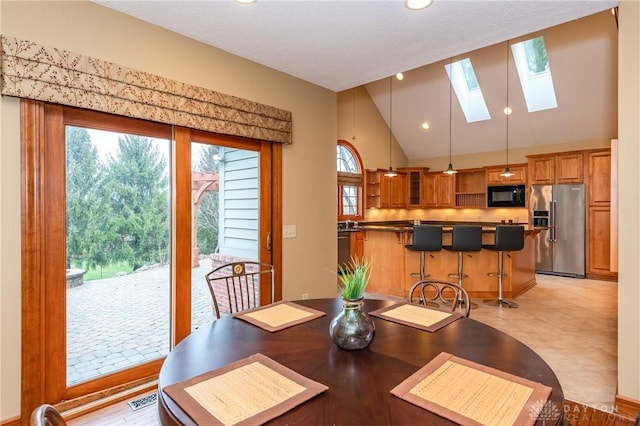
[{"left": 23, "top": 101, "right": 279, "bottom": 410}]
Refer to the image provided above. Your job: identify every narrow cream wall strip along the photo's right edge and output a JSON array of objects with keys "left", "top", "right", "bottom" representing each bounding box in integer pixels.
[{"left": 618, "top": 1, "right": 640, "bottom": 402}]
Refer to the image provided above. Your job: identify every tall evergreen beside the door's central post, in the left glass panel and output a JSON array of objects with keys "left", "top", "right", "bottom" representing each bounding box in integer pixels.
[{"left": 105, "top": 135, "right": 169, "bottom": 270}]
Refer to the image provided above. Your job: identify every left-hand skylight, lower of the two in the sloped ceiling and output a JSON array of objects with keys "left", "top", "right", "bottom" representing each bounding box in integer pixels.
[{"left": 444, "top": 58, "right": 491, "bottom": 123}]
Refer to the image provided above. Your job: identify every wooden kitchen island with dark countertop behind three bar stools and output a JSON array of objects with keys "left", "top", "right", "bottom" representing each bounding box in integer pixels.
[{"left": 350, "top": 221, "right": 539, "bottom": 299}]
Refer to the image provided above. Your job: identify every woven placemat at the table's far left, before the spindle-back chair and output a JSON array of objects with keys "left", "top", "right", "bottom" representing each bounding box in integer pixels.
[{"left": 233, "top": 302, "right": 326, "bottom": 333}]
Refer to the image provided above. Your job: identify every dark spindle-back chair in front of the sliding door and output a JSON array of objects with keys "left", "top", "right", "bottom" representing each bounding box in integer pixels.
[{"left": 205, "top": 261, "right": 273, "bottom": 318}]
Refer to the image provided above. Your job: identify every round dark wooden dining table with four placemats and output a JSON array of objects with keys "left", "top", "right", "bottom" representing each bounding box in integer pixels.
[{"left": 158, "top": 298, "right": 564, "bottom": 425}]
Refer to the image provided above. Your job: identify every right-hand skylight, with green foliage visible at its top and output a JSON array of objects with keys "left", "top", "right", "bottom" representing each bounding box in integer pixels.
[{"left": 511, "top": 36, "right": 558, "bottom": 112}]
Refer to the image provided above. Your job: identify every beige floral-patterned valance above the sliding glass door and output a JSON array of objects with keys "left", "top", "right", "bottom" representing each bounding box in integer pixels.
[{"left": 0, "top": 35, "right": 292, "bottom": 143}]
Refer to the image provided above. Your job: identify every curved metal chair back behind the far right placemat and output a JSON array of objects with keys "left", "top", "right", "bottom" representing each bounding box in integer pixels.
[{"left": 409, "top": 280, "right": 471, "bottom": 317}]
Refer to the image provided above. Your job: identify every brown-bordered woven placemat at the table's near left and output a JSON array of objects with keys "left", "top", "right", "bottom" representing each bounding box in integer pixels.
[{"left": 162, "top": 354, "right": 328, "bottom": 425}]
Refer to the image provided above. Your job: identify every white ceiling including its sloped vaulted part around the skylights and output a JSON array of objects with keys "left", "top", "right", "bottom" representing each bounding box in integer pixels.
[{"left": 95, "top": 0, "right": 618, "bottom": 159}]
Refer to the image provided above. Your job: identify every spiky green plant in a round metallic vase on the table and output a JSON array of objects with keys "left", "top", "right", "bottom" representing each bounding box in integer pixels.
[{"left": 329, "top": 257, "right": 376, "bottom": 350}]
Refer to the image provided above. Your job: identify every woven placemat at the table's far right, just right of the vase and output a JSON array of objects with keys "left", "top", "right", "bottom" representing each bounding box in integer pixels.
[{"left": 369, "top": 303, "right": 463, "bottom": 332}]
